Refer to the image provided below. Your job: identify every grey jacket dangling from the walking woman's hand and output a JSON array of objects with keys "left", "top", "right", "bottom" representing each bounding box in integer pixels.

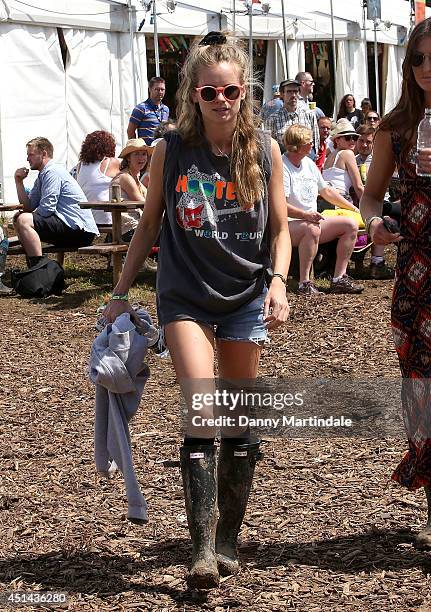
[{"left": 89, "top": 310, "right": 151, "bottom": 523}]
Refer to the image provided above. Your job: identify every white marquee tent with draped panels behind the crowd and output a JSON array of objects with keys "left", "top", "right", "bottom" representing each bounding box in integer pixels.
[{"left": 0, "top": 0, "right": 429, "bottom": 201}]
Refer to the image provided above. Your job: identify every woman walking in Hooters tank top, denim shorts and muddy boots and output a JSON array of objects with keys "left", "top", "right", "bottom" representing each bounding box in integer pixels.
[{"left": 105, "top": 32, "right": 291, "bottom": 588}]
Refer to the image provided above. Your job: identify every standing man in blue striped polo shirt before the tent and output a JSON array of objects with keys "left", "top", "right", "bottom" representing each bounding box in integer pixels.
[{"left": 127, "top": 77, "right": 169, "bottom": 146}]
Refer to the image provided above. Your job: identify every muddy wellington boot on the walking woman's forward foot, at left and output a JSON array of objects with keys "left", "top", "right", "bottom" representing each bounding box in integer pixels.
[{"left": 180, "top": 445, "right": 219, "bottom": 589}]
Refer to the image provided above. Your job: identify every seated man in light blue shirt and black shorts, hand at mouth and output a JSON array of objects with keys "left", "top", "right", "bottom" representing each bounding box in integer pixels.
[{"left": 14, "top": 137, "right": 99, "bottom": 267}]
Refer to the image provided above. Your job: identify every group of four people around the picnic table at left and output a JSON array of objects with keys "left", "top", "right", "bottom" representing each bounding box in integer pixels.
[{"left": 7, "top": 77, "right": 175, "bottom": 278}]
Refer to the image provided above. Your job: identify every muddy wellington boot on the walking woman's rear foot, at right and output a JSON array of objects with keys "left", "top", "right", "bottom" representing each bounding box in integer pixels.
[{"left": 216, "top": 440, "right": 261, "bottom": 576}]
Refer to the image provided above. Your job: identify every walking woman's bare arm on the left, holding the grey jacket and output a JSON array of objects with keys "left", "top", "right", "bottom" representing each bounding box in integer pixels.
[{"left": 103, "top": 140, "right": 166, "bottom": 321}]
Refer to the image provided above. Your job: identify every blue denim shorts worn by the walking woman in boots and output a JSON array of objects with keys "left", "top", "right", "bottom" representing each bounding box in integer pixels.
[{"left": 203, "top": 287, "right": 268, "bottom": 344}]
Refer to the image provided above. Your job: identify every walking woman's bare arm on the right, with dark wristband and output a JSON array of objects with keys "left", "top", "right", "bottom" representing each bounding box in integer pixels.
[{"left": 264, "top": 140, "right": 292, "bottom": 329}]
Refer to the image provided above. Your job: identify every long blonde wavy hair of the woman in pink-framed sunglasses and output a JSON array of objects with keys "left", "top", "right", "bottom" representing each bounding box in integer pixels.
[{"left": 177, "top": 32, "right": 264, "bottom": 210}]
